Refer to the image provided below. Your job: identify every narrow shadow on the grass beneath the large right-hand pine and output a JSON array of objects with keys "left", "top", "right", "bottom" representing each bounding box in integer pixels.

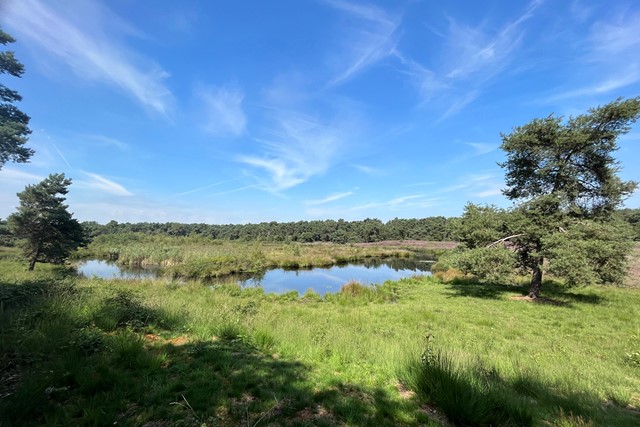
[{"left": 445, "top": 278, "right": 605, "bottom": 307}]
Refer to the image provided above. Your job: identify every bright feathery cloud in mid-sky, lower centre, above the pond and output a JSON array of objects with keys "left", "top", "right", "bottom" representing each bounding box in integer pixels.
[{"left": 237, "top": 112, "right": 349, "bottom": 193}]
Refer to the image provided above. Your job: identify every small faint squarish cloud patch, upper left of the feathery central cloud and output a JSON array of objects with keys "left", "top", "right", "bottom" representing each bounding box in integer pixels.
[{"left": 198, "top": 87, "right": 247, "bottom": 136}]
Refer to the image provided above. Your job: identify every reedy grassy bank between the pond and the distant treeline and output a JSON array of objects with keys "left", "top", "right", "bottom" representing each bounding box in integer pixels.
[{"left": 79, "top": 233, "right": 412, "bottom": 279}]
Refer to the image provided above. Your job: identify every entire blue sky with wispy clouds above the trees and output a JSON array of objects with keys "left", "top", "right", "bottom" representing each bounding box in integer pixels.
[{"left": 0, "top": 0, "right": 640, "bottom": 223}]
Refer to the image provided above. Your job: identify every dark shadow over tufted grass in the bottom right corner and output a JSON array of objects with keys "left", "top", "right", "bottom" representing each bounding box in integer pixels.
[{"left": 403, "top": 351, "right": 640, "bottom": 426}]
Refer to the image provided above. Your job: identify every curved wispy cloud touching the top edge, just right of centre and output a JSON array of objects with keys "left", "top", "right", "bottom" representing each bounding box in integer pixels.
[{"left": 325, "top": 0, "right": 401, "bottom": 86}]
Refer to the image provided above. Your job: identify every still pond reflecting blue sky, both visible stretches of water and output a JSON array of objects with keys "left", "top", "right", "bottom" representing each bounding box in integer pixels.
[{"left": 77, "top": 258, "right": 433, "bottom": 295}]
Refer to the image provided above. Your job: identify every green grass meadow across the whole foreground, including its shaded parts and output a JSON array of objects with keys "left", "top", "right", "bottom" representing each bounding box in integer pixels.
[{"left": 0, "top": 246, "right": 640, "bottom": 426}]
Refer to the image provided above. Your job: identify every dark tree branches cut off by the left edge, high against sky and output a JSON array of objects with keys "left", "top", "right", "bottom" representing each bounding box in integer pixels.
[{"left": 0, "top": 28, "right": 33, "bottom": 169}]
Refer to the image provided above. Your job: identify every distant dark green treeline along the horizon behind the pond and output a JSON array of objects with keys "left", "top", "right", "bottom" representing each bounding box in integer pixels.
[{"left": 82, "top": 216, "right": 456, "bottom": 243}]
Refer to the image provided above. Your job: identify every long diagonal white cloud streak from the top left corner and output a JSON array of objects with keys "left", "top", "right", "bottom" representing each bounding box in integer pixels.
[{"left": 2, "top": 0, "right": 173, "bottom": 116}]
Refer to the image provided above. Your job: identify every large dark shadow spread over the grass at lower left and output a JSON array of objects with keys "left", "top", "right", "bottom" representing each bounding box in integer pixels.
[{"left": 0, "top": 283, "right": 424, "bottom": 427}]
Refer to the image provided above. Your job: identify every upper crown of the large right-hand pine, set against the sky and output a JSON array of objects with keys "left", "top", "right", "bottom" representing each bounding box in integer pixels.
[{"left": 501, "top": 97, "right": 640, "bottom": 217}]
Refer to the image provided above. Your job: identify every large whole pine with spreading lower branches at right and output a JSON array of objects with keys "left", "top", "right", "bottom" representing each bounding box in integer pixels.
[{"left": 454, "top": 97, "right": 640, "bottom": 298}]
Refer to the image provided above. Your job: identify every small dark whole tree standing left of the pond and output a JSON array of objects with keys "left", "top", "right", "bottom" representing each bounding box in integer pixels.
[{"left": 8, "top": 174, "right": 85, "bottom": 270}]
